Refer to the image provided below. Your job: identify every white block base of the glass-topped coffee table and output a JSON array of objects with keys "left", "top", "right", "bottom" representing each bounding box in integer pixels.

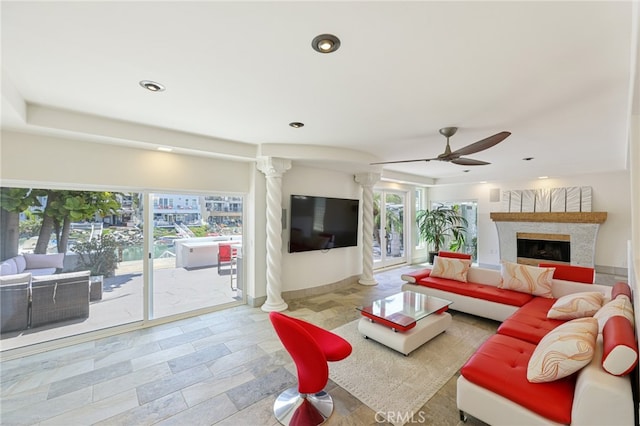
[{"left": 358, "top": 312, "right": 452, "bottom": 356}]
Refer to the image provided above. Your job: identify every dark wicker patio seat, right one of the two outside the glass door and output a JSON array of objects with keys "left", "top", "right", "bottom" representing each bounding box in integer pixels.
[{"left": 31, "top": 271, "right": 90, "bottom": 328}]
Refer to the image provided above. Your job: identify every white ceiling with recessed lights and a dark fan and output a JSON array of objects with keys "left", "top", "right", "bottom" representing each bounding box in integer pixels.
[{"left": 1, "top": 1, "right": 640, "bottom": 184}]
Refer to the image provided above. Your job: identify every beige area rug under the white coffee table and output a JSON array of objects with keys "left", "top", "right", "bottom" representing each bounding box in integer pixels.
[{"left": 329, "top": 316, "right": 495, "bottom": 426}]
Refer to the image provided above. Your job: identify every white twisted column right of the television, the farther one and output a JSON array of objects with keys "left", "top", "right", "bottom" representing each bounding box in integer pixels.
[{"left": 354, "top": 173, "right": 380, "bottom": 285}]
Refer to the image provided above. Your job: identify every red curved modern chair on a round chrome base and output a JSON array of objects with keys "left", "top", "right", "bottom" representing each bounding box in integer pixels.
[{"left": 269, "top": 312, "right": 351, "bottom": 426}]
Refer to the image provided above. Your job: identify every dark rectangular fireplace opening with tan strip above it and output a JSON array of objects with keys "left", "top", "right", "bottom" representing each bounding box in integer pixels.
[{"left": 517, "top": 233, "right": 571, "bottom": 264}]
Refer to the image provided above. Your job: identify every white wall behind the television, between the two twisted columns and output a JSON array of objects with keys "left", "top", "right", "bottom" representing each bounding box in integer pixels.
[{"left": 282, "top": 163, "right": 362, "bottom": 291}]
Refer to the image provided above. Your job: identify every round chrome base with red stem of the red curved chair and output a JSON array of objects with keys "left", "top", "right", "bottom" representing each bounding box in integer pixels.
[{"left": 273, "top": 387, "right": 333, "bottom": 426}]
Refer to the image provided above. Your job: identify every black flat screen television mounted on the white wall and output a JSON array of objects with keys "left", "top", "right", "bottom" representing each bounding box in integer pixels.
[{"left": 289, "top": 195, "right": 359, "bottom": 253}]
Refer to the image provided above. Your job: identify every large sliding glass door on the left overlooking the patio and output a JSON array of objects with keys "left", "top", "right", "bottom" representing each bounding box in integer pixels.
[{"left": 0, "top": 187, "right": 244, "bottom": 351}]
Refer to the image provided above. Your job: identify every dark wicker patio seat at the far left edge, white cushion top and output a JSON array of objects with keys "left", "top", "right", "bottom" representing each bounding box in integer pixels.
[{"left": 0, "top": 272, "right": 31, "bottom": 333}]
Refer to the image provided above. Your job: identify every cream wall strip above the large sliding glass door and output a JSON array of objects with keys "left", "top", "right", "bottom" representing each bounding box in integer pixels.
[{"left": 0, "top": 131, "right": 253, "bottom": 194}]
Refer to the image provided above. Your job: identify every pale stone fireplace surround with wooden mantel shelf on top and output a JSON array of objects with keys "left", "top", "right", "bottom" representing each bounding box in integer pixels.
[{"left": 490, "top": 212, "right": 607, "bottom": 267}]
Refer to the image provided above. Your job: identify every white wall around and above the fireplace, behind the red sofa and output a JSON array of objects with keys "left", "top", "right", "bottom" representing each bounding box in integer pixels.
[{"left": 429, "top": 172, "right": 631, "bottom": 268}]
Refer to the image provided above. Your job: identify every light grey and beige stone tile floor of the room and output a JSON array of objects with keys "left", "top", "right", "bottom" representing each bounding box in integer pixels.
[{"left": 0, "top": 267, "right": 497, "bottom": 426}]
